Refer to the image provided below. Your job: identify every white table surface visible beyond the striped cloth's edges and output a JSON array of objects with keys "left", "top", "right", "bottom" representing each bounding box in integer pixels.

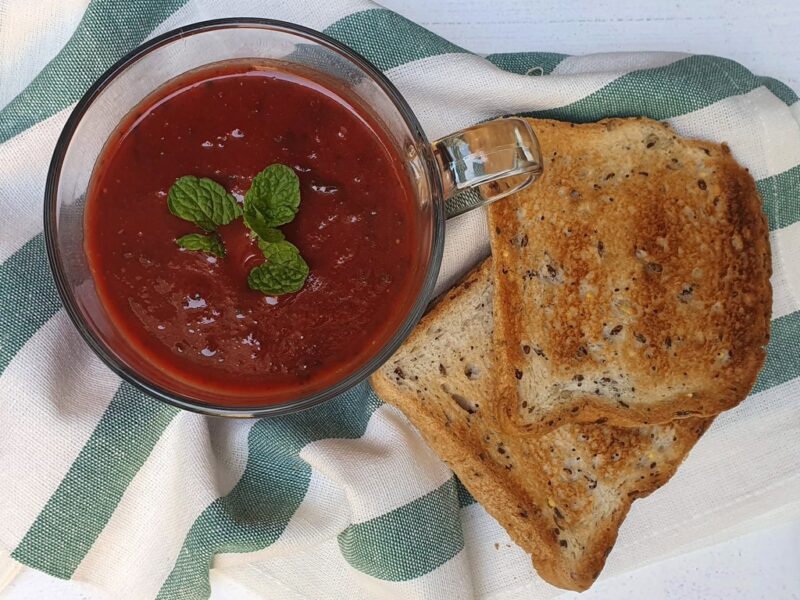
[{"left": 0, "top": 0, "right": 800, "bottom": 600}]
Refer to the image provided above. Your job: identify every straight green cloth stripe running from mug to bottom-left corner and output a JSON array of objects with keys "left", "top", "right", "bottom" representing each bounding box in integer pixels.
[{"left": 11, "top": 383, "right": 178, "bottom": 579}]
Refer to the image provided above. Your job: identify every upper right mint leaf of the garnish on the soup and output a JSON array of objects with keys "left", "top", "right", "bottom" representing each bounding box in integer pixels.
[{"left": 244, "top": 164, "right": 300, "bottom": 234}]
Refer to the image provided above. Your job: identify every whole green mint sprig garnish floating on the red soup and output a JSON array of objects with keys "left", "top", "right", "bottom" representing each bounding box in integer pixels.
[{"left": 167, "top": 164, "right": 308, "bottom": 296}]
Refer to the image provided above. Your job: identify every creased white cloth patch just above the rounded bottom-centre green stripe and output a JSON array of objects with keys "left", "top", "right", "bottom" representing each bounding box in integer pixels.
[{"left": 300, "top": 405, "right": 452, "bottom": 523}]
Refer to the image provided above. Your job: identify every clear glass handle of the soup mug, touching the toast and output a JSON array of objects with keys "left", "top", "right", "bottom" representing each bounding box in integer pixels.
[{"left": 432, "top": 117, "right": 542, "bottom": 219}]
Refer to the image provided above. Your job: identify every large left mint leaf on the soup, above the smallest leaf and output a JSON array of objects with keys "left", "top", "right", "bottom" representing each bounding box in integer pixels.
[{"left": 167, "top": 175, "right": 242, "bottom": 231}]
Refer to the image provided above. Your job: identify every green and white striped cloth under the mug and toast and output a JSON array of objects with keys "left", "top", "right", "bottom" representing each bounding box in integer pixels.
[{"left": 0, "top": 0, "right": 800, "bottom": 599}]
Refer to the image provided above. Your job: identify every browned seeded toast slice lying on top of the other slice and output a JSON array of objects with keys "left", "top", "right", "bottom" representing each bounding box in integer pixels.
[{"left": 489, "top": 119, "right": 772, "bottom": 435}]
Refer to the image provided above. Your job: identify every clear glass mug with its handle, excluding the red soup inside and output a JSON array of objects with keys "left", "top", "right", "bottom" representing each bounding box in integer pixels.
[{"left": 44, "top": 18, "right": 542, "bottom": 417}]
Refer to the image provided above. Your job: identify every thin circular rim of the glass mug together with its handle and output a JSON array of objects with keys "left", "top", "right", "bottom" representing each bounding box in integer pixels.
[{"left": 44, "top": 18, "right": 542, "bottom": 417}]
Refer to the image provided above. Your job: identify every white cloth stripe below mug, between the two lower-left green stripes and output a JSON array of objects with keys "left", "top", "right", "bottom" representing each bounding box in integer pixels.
[{"left": 73, "top": 412, "right": 256, "bottom": 598}]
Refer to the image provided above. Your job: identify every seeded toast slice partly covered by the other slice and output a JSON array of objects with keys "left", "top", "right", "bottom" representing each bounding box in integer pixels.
[{"left": 372, "top": 259, "right": 710, "bottom": 590}]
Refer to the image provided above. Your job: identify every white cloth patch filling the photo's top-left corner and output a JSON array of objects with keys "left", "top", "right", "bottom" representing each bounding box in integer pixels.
[{"left": 0, "top": 0, "right": 89, "bottom": 108}]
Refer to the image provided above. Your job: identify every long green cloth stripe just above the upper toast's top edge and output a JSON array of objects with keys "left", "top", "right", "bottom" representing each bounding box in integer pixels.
[{"left": 526, "top": 56, "right": 792, "bottom": 123}]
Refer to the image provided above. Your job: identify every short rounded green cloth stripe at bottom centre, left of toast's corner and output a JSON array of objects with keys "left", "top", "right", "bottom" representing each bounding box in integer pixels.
[{"left": 338, "top": 479, "right": 464, "bottom": 581}]
